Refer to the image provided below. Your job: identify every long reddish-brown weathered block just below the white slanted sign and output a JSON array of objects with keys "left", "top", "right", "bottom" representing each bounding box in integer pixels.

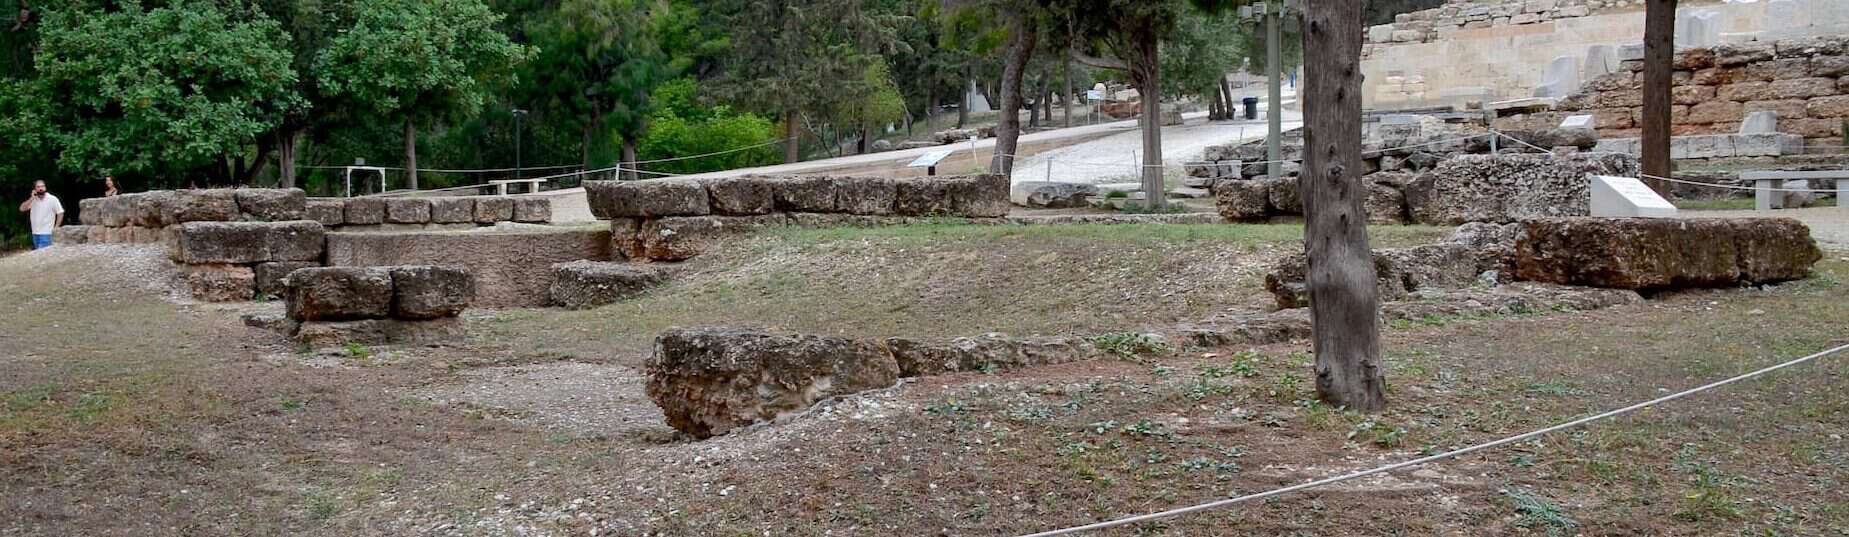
[{"left": 1514, "top": 219, "right": 1823, "bottom": 291}]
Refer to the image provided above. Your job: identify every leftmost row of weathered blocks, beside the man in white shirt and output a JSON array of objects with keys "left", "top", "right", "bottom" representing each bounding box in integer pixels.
[{"left": 78, "top": 189, "right": 307, "bottom": 228}]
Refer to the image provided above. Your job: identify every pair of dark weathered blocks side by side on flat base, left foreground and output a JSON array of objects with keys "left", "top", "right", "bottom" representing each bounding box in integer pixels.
[{"left": 276, "top": 267, "right": 475, "bottom": 348}]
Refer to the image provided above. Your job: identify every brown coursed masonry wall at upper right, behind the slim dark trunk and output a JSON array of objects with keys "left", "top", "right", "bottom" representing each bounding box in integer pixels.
[{"left": 1496, "top": 35, "right": 1849, "bottom": 145}]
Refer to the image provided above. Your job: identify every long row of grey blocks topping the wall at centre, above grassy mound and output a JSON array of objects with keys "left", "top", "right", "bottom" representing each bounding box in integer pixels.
[{"left": 584, "top": 176, "right": 1010, "bottom": 220}]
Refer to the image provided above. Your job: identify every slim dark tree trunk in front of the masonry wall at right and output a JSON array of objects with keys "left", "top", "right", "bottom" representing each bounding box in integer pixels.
[{"left": 1644, "top": 0, "right": 1675, "bottom": 196}]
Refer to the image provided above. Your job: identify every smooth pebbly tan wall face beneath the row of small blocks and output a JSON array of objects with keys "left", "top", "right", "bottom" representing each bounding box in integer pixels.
[{"left": 327, "top": 228, "right": 612, "bottom": 307}]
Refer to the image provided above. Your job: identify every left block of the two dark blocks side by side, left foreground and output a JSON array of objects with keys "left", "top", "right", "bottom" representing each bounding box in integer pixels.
[{"left": 283, "top": 267, "right": 392, "bottom": 320}]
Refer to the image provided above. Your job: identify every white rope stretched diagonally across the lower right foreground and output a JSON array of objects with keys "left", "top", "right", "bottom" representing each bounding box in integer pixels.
[{"left": 1022, "top": 344, "right": 1849, "bottom": 537}]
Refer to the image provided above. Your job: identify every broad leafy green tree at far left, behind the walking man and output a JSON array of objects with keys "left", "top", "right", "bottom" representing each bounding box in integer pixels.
[{"left": 35, "top": 2, "right": 301, "bottom": 183}]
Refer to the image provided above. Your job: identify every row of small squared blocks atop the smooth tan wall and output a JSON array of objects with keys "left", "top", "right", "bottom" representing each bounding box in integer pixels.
[{"left": 307, "top": 196, "right": 553, "bottom": 226}]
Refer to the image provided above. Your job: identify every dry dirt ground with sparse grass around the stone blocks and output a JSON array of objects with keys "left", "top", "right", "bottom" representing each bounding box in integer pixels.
[{"left": 0, "top": 226, "right": 1849, "bottom": 535}]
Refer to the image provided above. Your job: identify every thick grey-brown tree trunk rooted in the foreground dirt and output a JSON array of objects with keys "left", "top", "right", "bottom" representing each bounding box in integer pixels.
[{"left": 1298, "top": 0, "right": 1387, "bottom": 413}]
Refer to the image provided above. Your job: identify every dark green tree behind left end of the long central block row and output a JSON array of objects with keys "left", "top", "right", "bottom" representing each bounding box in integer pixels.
[{"left": 527, "top": 0, "right": 673, "bottom": 178}]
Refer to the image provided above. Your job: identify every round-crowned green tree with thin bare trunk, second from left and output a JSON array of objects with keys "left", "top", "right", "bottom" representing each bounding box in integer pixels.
[{"left": 314, "top": 0, "right": 531, "bottom": 189}]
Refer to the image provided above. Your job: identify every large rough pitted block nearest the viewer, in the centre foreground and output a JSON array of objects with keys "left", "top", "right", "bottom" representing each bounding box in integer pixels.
[{"left": 645, "top": 328, "right": 899, "bottom": 437}]
